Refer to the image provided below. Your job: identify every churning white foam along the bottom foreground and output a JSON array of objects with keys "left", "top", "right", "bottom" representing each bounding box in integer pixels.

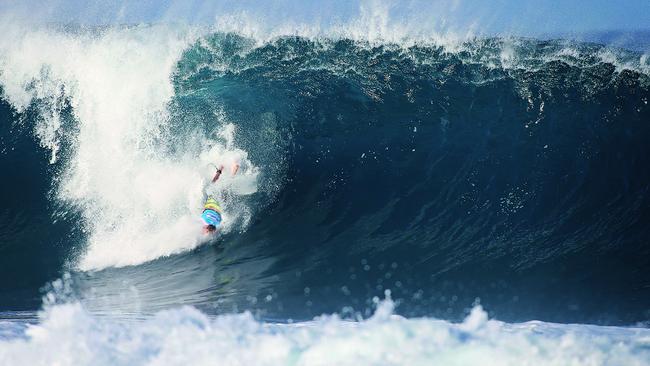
[{"left": 0, "top": 300, "right": 650, "bottom": 365}]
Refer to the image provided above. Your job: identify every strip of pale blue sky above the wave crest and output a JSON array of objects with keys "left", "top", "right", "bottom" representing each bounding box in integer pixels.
[{"left": 0, "top": 0, "right": 650, "bottom": 35}]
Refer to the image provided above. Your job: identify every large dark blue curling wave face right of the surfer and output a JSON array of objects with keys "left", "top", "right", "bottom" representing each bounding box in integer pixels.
[{"left": 168, "top": 36, "right": 650, "bottom": 323}]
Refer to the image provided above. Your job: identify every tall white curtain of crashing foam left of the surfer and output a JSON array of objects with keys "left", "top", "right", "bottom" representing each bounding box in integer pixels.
[{"left": 0, "top": 22, "right": 254, "bottom": 270}]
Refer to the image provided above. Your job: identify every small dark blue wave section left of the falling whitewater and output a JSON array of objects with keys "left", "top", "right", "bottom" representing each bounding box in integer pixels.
[{"left": 0, "top": 100, "right": 78, "bottom": 310}]
